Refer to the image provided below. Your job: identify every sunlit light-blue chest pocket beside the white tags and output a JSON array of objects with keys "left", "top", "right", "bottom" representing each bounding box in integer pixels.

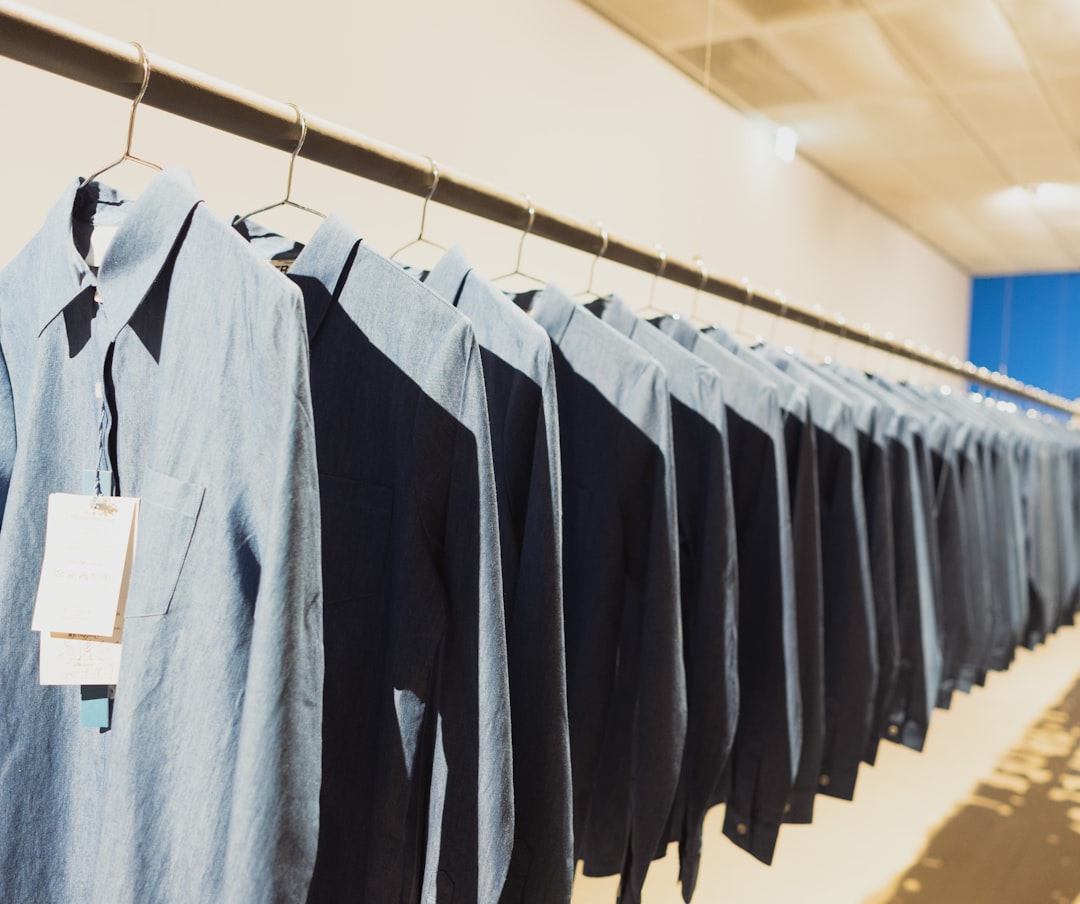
[{"left": 124, "top": 469, "right": 205, "bottom": 619}]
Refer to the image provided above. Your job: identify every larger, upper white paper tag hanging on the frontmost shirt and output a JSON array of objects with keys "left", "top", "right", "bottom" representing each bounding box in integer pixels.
[{"left": 30, "top": 493, "right": 138, "bottom": 635}]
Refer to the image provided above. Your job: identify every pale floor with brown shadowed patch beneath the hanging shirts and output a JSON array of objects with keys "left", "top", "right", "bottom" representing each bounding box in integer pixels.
[{"left": 572, "top": 628, "right": 1080, "bottom": 904}]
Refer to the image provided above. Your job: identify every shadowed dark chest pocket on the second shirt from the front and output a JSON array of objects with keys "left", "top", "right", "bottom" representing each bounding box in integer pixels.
[{"left": 319, "top": 474, "right": 394, "bottom": 606}]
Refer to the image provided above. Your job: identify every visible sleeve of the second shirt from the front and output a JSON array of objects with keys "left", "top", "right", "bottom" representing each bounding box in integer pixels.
[{"left": 422, "top": 332, "right": 514, "bottom": 904}]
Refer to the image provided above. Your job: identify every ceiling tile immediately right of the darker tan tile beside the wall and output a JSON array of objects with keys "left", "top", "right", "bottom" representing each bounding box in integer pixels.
[{"left": 768, "top": 12, "right": 921, "bottom": 98}]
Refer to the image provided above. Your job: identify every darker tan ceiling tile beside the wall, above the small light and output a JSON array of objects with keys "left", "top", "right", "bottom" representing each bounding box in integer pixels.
[{"left": 679, "top": 38, "right": 814, "bottom": 107}]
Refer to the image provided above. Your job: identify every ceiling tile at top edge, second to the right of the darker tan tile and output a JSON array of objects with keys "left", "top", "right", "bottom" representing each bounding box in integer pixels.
[{"left": 879, "top": 0, "right": 1027, "bottom": 85}]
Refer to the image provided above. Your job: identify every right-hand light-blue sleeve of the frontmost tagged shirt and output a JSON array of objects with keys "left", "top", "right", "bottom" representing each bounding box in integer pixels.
[{"left": 225, "top": 289, "right": 323, "bottom": 904}]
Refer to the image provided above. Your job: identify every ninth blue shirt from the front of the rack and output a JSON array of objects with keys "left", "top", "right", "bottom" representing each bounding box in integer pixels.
[{"left": 802, "top": 361, "right": 900, "bottom": 766}]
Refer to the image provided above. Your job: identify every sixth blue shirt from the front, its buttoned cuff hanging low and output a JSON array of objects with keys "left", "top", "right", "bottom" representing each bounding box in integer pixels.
[{"left": 654, "top": 318, "right": 802, "bottom": 863}]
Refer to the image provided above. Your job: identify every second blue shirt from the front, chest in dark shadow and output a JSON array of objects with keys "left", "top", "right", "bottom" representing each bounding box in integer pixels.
[{"left": 240, "top": 216, "right": 514, "bottom": 904}]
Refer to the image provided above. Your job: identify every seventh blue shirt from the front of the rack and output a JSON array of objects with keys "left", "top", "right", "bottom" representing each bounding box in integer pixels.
[{"left": 703, "top": 325, "right": 825, "bottom": 824}]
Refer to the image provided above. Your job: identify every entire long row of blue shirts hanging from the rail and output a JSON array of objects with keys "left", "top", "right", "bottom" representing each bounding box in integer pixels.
[{"left": 0, "top": 164, "right": 1080, "bottom": 904}]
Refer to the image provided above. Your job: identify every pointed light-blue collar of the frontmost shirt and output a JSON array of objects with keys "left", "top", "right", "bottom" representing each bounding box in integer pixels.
[{"left": 37, "top": 167, "right": 201, "bottom": 340}]
